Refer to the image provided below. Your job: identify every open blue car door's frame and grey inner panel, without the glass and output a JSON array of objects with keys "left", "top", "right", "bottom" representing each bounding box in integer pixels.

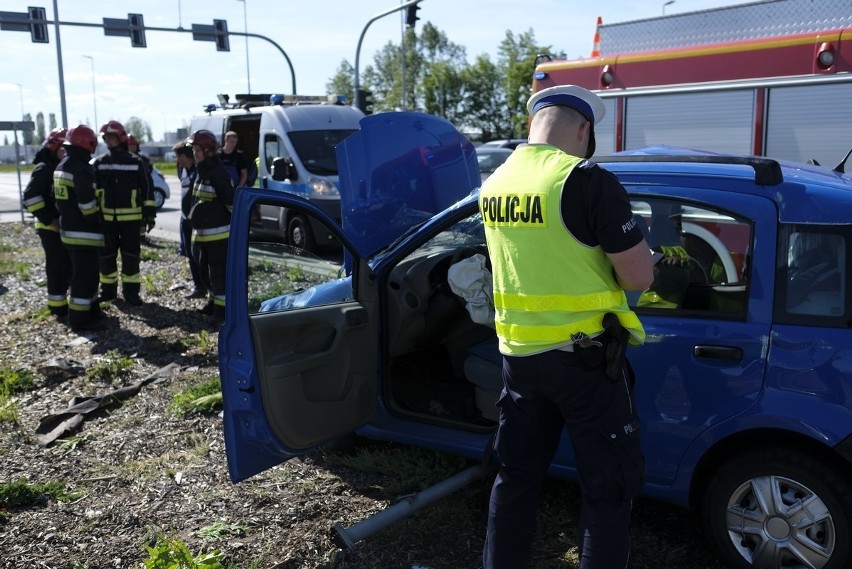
[{"left": 219, "top": 188, "right": 378, "bottom": 482}]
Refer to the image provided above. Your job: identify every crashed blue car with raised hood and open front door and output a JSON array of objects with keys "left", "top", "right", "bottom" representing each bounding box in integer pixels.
[{"left": 219, "top": 113, "right": 852, "bottom": 569}]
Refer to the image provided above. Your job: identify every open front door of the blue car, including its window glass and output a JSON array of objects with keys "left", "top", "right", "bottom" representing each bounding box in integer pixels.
[{"left": 219, "top": 188, "right": 378, "bottom": 482}]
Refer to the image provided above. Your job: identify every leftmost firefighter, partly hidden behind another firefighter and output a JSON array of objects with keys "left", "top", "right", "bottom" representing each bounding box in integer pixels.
[{"left": 24, "top": 128, "right": 71, "bottom": 319}]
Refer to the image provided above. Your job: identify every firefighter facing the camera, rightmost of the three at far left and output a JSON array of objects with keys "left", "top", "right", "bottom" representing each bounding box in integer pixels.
[{"left": 93, "top": 121, "right": 157, "bottom": 306}]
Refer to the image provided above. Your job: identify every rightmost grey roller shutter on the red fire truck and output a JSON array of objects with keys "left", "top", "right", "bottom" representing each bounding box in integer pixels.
[{"left": 766, "top": 82, "right": 852, "bottom": 168}]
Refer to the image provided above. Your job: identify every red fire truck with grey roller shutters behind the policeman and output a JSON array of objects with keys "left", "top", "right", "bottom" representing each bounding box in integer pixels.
[{"left": 532, "top": 0, "right": 852, "bottom": 167}]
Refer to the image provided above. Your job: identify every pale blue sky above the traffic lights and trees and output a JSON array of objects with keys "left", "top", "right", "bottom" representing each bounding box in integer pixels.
[{"left": 0, "top": 0, "right": 746, "bottom": 140}]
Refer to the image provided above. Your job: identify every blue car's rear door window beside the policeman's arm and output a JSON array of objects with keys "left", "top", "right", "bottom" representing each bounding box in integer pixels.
[{"left": 628, "top": 198, "right": 752, "bottom": 318}]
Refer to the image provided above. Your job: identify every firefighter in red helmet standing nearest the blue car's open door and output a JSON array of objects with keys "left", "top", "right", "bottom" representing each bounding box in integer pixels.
[{"left": 187, "top": 130, "right": 234, "bottom": 317}]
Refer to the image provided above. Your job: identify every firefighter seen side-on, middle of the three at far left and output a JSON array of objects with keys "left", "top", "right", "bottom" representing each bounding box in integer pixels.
[{"left": 53, "top": 124, "right": 104, "bottom": 330}]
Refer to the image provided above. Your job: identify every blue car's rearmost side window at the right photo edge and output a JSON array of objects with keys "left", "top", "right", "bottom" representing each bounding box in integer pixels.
[{"left": 775, "top": 225, "right": 852, "bottom": 328}]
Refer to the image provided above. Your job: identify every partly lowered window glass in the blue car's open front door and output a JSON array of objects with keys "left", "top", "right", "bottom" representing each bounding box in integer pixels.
[{"left": 247, "top": 229, "right": 352, "bottom": 314}]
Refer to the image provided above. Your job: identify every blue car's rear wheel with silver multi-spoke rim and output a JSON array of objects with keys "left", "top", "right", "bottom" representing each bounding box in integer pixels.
[{"left": 701, "top": 448, "right": 852, "bottom": 569}]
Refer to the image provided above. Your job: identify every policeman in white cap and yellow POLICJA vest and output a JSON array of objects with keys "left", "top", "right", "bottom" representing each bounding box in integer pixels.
[{"left": 480, "top": 85, "right": 653, "bottom": 569}]
